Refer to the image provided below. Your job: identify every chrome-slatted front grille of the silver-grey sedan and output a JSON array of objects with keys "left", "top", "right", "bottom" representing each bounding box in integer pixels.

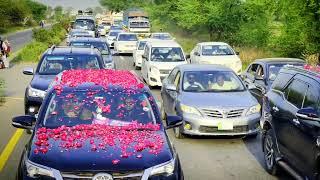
[{"left": 201, "top": 109, "right": 244, "bottom": 118}]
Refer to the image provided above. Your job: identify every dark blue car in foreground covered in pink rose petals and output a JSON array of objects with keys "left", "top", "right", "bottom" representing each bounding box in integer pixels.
[{"left": 12, "top": 70, "right": 183, "bottom": 180}]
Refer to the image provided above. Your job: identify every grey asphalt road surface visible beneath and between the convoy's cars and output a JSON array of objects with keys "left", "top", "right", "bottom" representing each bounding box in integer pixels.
[{"left": 0, "top": 56, "right": 290, "bottom": 180}]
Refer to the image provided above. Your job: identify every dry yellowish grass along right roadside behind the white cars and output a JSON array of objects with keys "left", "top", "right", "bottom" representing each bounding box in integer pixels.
[{"left": 151, "top": 19, "right": 276, "bottom": 70}]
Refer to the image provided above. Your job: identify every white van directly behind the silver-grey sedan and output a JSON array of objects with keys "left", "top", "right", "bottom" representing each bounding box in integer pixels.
[{"left": 141, "top": 40, "right": 187, "bottom": 86}]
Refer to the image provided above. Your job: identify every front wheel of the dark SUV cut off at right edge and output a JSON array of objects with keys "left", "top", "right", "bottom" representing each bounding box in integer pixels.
[{"left": 262, "top": 129, "right": 279, "bottom": 175}]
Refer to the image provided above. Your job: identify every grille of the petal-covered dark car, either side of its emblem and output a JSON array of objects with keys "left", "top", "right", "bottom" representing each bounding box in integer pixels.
[{"left": 61, "top": 171, "right": 143, "bottom": 180}]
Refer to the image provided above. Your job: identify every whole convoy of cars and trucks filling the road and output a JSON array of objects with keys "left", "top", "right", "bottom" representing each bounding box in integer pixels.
[{"left": 12, "top": 8, "right": 320, "bottom": 179}]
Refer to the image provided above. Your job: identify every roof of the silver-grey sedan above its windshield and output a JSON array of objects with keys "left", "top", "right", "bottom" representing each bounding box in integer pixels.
[{"left": 177, "top": 64, "right": 233, "bottom": 71}]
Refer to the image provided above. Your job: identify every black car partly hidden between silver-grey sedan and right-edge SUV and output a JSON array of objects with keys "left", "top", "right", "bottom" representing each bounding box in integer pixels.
[{"left": 241, "top": 58, "right": 305, "bottom": 104}]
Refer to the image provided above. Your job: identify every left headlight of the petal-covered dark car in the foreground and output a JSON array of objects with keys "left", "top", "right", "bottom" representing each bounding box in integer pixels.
[{"left": 25, "top": 160, "right": 55, "bottom": 178}]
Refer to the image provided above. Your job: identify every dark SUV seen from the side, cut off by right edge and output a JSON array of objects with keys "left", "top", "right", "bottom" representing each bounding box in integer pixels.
[{"left": 260, "top": 66, "right": 320, "bottom": 179}]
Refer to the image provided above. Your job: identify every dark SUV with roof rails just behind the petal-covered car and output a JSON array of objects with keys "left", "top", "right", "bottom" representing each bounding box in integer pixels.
[{"left": 23, "top": 46, "right": 105, "bottom": 115}]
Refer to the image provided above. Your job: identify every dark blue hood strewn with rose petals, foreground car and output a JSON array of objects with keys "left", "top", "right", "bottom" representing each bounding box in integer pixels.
[{"left": 28, "top": 124, "right": 173, "bottom": 172}]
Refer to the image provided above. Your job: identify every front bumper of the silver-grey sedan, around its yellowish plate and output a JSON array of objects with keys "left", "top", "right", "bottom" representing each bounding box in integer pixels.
[{"left": 181, "top": 114, "right": 260, "bottom": 136}]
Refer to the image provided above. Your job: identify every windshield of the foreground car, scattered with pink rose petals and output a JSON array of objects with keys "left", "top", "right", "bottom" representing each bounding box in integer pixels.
[{"left": 43, "top": 89, "right": 156, "bottom": 128}]
